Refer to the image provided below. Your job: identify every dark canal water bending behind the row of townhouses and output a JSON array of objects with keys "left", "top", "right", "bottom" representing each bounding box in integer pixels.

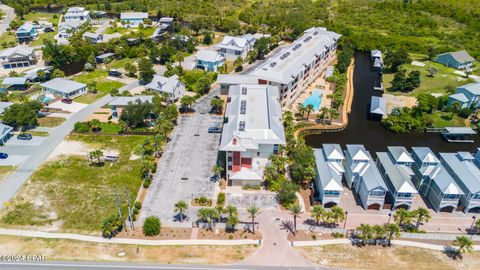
[{"left": 305, "top": 53, "right": 480, "bottom": 155}]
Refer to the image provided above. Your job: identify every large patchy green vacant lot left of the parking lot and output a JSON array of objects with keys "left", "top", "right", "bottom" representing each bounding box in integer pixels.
[{"left": 0, "top": 135, "right": 147, "bottom": 232}]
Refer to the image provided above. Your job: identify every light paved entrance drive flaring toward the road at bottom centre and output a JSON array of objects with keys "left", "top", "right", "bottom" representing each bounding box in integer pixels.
[{"left": 239, "top": 210, "right": 314, "bottom": 267}]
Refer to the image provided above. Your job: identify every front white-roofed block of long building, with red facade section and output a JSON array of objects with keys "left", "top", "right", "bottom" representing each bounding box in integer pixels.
[{"left": 220, "top": 85, "right": 285, "bottom": 186}]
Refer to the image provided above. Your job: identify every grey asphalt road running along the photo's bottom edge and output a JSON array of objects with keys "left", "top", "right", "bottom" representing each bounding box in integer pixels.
[{"left": 0, "top": 262, "right": 324, "bottom": 270}]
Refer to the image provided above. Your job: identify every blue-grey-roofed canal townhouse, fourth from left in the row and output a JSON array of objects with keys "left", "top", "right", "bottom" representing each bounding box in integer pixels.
[{"left": 412, "top": 147, "right": 463, "bottom": 212}]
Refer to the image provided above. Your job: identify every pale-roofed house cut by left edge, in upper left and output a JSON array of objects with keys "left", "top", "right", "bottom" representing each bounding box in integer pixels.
[{"left": 0, "top": 45, "right": 37, "bottom": 69}]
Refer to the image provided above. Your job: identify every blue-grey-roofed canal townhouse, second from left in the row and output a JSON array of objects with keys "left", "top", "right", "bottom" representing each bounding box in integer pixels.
[{"left": 345, "top": 144, "right": 388, "bottom": 210}]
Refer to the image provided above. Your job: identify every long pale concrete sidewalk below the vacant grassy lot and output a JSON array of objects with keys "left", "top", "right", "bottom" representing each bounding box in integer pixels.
[{"left": 0, "top": 229, "right": 260, "bottom": 246}]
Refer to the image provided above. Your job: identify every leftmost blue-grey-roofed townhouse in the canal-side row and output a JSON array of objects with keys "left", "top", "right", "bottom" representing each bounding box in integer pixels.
[{"left": 313, "top": 144, "right": 345, "bottom": 207}]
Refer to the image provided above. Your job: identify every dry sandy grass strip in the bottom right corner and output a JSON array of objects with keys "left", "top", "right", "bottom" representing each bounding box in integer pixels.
[{"left": 296, "top": 245, "right": 480, "bottom": 270}]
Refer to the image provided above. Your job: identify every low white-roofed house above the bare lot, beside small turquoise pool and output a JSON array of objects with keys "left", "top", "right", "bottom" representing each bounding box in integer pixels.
[{"left": 40, "top": 78, "right": 87, "bottom": 99}]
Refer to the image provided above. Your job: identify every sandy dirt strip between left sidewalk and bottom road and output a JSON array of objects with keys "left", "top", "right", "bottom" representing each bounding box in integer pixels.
[{"left": 0, "top": 236, "right": 257, "bottom": 264}]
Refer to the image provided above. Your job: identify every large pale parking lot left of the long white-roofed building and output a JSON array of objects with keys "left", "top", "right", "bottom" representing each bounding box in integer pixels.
[{"left": 140, "top": 90, "right": 223, "bottom": 224}]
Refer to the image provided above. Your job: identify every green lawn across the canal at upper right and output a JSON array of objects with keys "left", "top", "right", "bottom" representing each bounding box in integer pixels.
[{"left": 383, "top": 54, "right": 469, "bottom": 96}]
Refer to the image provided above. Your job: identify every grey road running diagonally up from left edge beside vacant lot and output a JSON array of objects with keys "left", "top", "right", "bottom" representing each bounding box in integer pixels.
[{"left": 0, "top": 95, "right": 112, "bottom": 209}]
